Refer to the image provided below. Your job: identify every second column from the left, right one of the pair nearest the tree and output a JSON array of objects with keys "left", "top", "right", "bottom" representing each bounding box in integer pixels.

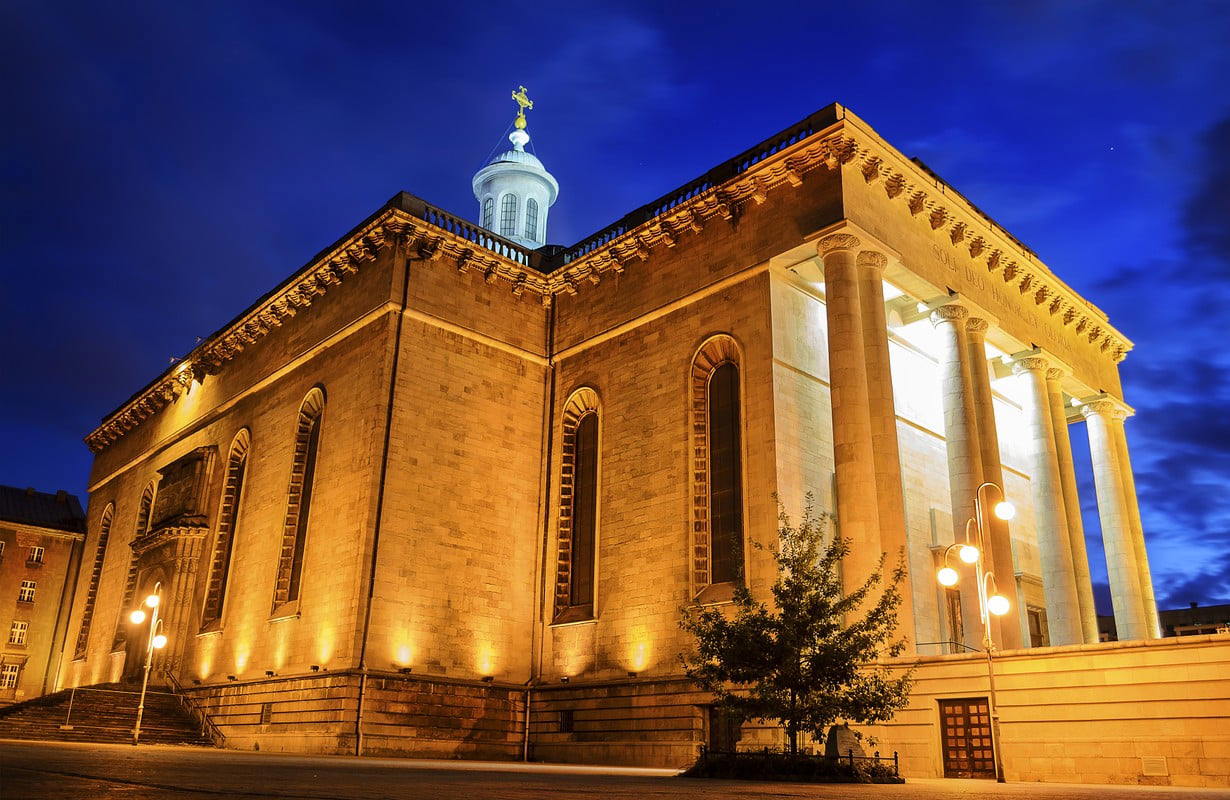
[{"left": 857, "top": 250, "right": 915, "bottom": 639}]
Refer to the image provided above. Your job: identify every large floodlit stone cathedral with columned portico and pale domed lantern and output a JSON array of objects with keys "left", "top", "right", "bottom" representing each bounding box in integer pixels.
[{"left": 60, "top": 90, "right": 1210, "bottom": 772}]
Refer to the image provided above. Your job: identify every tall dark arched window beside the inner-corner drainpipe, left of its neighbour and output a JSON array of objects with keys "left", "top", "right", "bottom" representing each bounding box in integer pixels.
[{"left": 555, "top": 388, "right": 599, "bottom": 622}]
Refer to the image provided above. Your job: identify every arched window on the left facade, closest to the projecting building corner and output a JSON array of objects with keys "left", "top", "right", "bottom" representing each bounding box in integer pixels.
[{"left": 273, "top": 388, "right": 325, "bottom": 613}]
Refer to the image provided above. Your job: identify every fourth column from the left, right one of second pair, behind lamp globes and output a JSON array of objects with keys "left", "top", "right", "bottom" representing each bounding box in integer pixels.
[{"left": 966, "top": 316, "right": 1023, "bottom": 650}]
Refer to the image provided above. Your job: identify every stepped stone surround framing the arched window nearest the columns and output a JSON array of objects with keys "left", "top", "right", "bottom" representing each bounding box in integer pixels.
[{"left": 689, "top": 334, "right": 747, "bottom": 603}]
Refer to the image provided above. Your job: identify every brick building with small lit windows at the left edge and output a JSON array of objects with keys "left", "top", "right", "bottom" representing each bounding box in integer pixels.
[{"left": 0, "top": 486, "right": 85, "bottom": 705}]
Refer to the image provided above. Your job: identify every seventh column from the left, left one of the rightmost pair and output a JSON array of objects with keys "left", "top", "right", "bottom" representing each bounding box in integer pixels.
[{"left": 1081, "top": 400, "right": 1153, "bottom": 641}]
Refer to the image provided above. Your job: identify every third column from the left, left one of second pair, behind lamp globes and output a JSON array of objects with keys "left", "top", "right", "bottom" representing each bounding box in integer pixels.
[{"left": 931, "top": 304, "right": 983, "bottom": 647}]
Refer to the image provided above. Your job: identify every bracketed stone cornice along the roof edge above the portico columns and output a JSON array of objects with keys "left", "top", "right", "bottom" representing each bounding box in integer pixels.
[{"left": 841, "top": 126, "right": 1132, "bottom": 363}]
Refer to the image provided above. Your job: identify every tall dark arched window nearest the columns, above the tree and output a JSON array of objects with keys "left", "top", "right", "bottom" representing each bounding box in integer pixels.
[{"left": 691, "top": 335, "right": 743, "bottom": 599}]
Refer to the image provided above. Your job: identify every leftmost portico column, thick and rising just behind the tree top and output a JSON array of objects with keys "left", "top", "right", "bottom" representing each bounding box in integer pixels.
[{"left": 817, "top": 234, "right": 881, "bottom": 600}]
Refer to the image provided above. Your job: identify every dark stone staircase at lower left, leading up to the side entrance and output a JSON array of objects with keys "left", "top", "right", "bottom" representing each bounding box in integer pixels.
[{"left": 0, "top": 683, "right": 213, "bottom": 747}]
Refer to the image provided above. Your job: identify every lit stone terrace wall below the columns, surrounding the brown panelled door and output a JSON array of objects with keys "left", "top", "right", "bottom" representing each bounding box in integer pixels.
[{"left": 867, "top": 634, "right": 1230, "bottom": 786}]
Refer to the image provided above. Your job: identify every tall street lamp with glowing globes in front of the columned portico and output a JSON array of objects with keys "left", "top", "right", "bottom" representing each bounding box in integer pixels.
[{"left": 936, "top": 481, "right": 1016, "bottom": 783}]
